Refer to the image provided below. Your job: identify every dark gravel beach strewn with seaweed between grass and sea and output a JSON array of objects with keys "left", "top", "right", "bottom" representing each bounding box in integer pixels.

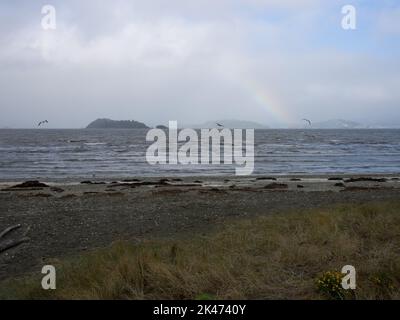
[{"left": 0, "top": 175, "right": 400, "bottom": 279}]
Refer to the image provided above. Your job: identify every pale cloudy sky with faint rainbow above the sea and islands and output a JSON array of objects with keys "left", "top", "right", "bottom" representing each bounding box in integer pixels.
[{"left": 0, "top": 0, "right": 400, "bottom": 128}]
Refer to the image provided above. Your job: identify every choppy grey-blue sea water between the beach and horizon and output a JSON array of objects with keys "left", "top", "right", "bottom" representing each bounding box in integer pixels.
[{"left": 0, "top": 129, "right": 400, "bottom": 181}]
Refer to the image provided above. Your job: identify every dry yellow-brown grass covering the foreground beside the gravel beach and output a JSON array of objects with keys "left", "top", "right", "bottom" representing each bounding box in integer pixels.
[{"left": 0, "top": 202, "right": 400, "bottom": 299}]
